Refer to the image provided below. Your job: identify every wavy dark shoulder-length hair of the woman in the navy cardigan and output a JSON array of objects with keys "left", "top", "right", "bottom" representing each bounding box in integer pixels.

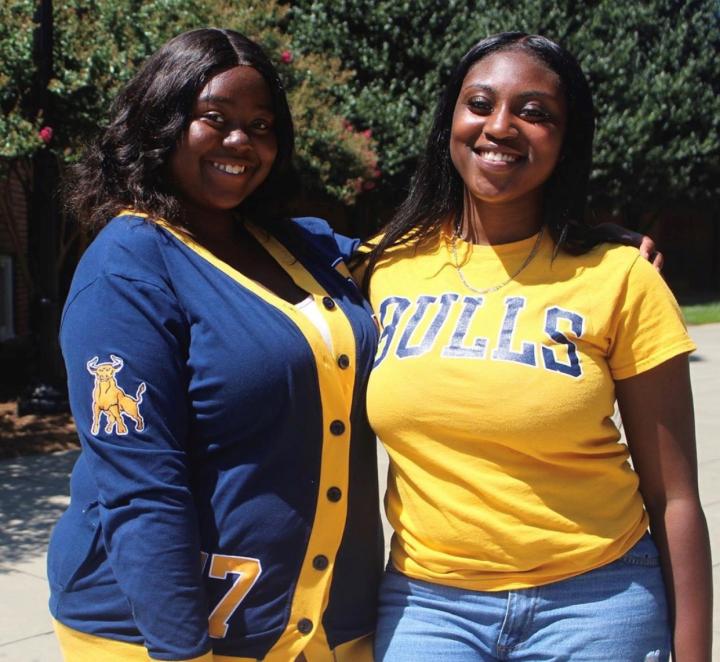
[{"left": 66, "top": 28, "right": 297, "bottom": 229}]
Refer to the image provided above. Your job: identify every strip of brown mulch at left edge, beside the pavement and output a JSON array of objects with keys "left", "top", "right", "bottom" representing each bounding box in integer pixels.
[{"left": 0, "top": 402, "right": 79, "bottom": 459}]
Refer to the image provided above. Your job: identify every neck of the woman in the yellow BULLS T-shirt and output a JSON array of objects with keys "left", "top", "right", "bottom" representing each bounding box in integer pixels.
[{"left": 456, "top": 189, "right": 542, "bottom": 245}]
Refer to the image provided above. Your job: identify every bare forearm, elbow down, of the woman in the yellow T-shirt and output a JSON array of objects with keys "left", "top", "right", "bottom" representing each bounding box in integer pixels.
[{"left": 648, "top": 497, "right": 713, "bottom": 662}]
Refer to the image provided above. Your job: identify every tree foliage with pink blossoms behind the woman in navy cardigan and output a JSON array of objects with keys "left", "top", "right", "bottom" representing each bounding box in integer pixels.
[{"left": 0, "top": 0, "right": 377, "bottom": 203}]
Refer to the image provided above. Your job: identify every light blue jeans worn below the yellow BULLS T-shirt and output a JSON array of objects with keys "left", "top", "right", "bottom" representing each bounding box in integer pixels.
[{"left": 375, "top": 535, "right": 670, "bottom": 662}]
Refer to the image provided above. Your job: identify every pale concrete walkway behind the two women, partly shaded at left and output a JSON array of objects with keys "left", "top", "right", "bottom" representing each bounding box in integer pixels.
[{"left": 0, "top": 324, "right": 720, "bottom": 662}]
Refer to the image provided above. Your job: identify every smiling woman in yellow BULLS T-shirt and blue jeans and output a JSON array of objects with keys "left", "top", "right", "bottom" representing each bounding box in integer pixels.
[{"left": 365, "top": 32, "right": 712, "bottom": 662}]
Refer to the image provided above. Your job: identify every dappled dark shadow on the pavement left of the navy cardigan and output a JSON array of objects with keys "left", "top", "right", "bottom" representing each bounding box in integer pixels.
[{"left": 0, "top": 451, "right": 79, "bottom": 574}]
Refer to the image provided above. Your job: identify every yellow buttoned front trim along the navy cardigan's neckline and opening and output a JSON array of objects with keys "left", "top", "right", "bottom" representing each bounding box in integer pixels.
[{"left": 120, "top": 210, "right": 360, "bottom": 662}]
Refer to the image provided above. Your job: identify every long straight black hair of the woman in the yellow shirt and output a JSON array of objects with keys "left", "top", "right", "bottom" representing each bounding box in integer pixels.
[{"left": 361, "top": 32, "right": 599, "bottom": 289}]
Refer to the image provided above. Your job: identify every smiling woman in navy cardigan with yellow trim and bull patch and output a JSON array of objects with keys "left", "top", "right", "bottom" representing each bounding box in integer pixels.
[{"left": 48, "top": 29, "right": 382, "bottom": 662}]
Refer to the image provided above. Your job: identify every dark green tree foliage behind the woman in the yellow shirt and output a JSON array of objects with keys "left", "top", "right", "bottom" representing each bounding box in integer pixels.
[{"left": 288, "top": 0, "right": 720, "bottom": 223}]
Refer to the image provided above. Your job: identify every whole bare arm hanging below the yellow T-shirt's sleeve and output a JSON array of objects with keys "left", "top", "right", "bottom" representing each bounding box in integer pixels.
[{"left": 615, "top": 355, "right": 712, "bottom": 662}]
